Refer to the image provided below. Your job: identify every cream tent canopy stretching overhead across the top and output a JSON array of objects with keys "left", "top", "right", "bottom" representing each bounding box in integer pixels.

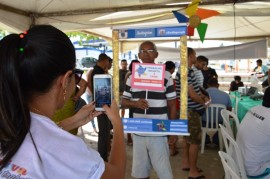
[{"left": 0, "top": 0, "right": 270, "bottom": 40}]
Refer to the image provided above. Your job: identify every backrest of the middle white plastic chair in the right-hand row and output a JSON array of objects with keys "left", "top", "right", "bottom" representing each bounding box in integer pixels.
[{"left": 219, "top": 124, "right": 247, "bottom": 179}]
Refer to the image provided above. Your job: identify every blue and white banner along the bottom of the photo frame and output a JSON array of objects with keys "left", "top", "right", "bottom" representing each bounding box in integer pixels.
[{"left": 122, "top": 118, "right": 189, "bottom": 136}]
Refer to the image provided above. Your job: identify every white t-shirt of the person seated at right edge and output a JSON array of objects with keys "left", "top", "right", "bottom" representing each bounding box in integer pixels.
[{"left": 236, "top": 106, "right": 270, "bottom": 176}]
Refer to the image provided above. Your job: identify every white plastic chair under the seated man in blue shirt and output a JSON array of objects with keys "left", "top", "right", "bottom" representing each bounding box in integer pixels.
[{"left": 201, "top": 104, "right": 226, "bottom": 153}]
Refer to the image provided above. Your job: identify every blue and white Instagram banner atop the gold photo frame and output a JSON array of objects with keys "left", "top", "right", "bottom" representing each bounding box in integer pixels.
[{"left": 119, "top": 26, "right": 187, "bottom": 39}]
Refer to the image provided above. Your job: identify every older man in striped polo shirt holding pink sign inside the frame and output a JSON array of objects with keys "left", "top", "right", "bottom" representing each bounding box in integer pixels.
[{"left": 122, "top": 41, "right": 176, "bottom": 179}]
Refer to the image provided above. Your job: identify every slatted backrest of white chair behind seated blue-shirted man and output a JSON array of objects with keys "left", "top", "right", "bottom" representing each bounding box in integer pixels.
[{"left": 205, "top": 104, "right": 226, "bottom": 130}]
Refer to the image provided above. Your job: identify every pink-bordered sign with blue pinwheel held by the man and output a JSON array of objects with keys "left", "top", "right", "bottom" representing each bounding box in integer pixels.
[{"left": 131, "top": 63, "right": 165, "bottom": 91}]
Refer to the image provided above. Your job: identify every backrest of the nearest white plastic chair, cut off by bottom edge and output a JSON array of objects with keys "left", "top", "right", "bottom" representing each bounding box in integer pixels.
[{"left": 218, "top": 151, "right": 241, "bottom": 179}]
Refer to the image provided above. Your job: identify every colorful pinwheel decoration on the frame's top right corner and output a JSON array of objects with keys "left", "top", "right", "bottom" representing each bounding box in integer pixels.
[{"left": 173, "top": 0, "right": 220, "bottom": 42}]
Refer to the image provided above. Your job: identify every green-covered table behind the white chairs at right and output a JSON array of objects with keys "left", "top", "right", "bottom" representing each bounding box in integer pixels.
[{"left": 231, "top": 94, "right": 262, "bottom": 123}]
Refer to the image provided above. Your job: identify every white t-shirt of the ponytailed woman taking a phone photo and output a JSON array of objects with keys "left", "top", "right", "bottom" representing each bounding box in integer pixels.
[{"left": 0, "top": 113, "right": 105, "bottom": 179}]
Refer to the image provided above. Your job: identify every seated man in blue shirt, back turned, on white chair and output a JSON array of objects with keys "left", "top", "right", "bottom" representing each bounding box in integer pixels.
[{"left": 202, "top": 78, "right": 232, "bottom": 145}]
